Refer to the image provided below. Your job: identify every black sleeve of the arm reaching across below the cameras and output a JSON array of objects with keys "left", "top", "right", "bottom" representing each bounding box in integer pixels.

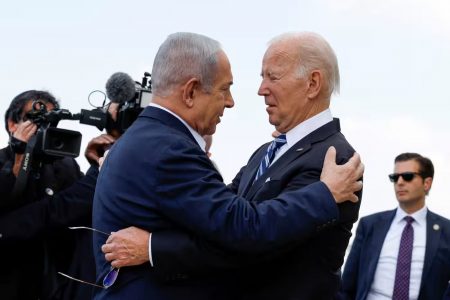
[{"left": 0, "top": 167, "right": 98, "bottom": 245}]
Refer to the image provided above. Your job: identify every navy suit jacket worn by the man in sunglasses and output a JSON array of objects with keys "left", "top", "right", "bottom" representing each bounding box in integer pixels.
[{"left": 341, "top": 210, "right": 450, "bottom": 300}]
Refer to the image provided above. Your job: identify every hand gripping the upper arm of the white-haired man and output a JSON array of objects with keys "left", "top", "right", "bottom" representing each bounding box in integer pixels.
[{"left": 320, "top": 147, "right": 364, "bottom": 203}]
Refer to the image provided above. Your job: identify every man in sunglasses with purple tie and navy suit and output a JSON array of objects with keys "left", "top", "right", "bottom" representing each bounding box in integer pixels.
[{"left": 341, "top": 153, "right": 450, "bottom": 300}]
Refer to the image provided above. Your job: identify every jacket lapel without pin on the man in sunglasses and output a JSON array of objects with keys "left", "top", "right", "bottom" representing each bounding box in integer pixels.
[{"left": 365, "top": 209, "right": 397, "bottom": 289}]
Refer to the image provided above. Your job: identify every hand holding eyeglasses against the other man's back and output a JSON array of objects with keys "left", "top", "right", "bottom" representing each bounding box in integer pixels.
[{"left": 102, "top": 227, "right": 151, "bottom": 268}]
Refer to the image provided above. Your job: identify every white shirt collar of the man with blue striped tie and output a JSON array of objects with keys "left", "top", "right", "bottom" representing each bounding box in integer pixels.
[{"left": 286, "top": 108, "right": 333, "bottom": 148}]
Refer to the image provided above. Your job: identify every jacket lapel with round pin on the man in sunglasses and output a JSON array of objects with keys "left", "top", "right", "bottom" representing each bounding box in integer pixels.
[{"left": 420, "top": 211, "right": 442, "bottom": 289}]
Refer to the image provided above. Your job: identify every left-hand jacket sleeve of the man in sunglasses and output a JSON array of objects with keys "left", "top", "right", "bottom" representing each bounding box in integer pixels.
[{"left": 339, "top": 218, "right": 365, "bottom": 299}]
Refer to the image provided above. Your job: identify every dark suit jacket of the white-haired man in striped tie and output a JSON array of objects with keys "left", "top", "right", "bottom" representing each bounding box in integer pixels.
[{"left": 152, "top": 119, "right": 361, "bottom": 300}]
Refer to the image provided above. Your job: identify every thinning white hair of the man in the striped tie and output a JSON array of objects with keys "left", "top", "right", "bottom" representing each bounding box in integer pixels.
[{"left": 269, "top": 32, "right": 340, "bottom": 96}]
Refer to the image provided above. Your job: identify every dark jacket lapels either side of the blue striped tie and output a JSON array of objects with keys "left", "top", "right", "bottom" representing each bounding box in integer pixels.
[{"left": 244, "top": 119, "right": 340, "bottom": 200}]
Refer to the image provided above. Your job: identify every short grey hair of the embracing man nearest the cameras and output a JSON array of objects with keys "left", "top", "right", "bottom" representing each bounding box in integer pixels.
[{"left": 152, "top": 32, "right": 222, "bottom": 96}]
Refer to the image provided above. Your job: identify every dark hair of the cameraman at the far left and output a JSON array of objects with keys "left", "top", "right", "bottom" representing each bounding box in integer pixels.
[{"left": 5, "top": 90, "right": 59, "bottom": 132}]
